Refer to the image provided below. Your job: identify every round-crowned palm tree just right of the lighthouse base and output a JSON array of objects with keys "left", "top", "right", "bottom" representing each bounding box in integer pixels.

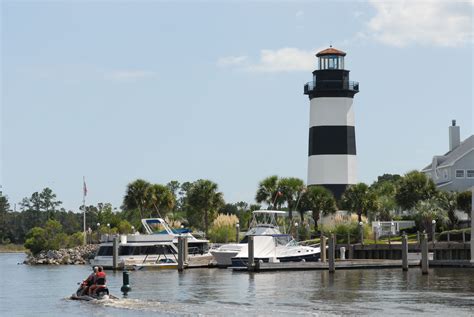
[{"left": 341, "top": 183, "right": 378, "bottom": 222}]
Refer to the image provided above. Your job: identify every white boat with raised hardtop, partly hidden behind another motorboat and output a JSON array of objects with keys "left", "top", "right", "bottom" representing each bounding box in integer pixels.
[{"left": 210, "top": 210, "right": 286, "bottom": 267}]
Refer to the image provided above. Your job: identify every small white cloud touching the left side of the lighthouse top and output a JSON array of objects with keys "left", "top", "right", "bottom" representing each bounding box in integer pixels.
[{"left": 217, "top": 47, "right": 317, "bottom": 72}]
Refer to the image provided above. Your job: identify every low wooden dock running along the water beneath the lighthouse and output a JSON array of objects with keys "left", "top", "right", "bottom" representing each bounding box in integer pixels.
[{"left": 232, "top": 259, "right": 420, "bottom": 272}]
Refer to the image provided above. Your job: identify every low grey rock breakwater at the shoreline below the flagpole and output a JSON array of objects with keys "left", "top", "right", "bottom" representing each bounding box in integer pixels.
[{"left": 23, "top": 244, "right": 99, "bottom": 265}]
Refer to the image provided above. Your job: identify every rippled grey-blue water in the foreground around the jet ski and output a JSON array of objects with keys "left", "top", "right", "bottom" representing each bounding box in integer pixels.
[{"left": 0, "top": 254, "right": 474, "bottom": 316}]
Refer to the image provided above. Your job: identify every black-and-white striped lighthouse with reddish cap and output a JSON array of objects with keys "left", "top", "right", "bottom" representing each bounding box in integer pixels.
[{"left": 304, "top": 47, "right": 359, "bottom": 198}]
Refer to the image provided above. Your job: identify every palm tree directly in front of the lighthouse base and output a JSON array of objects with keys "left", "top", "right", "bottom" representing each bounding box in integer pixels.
[{"left": 298, "top": 186, "right": 337, "bottom": 230}]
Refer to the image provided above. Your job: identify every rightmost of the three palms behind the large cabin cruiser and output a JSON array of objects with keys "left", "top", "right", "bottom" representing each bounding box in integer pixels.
[{"left": 186, "top": 179, "right": 225, "bottom": 236}]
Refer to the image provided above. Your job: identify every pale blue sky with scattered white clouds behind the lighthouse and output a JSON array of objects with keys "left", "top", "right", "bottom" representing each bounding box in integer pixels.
[{"left": 0, "top": 0, "right": 474, "bottom": 210}]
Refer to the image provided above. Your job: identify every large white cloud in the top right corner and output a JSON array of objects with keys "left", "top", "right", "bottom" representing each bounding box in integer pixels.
[{"left": 367, "top": 0, "right": 474, "bottom": 47}]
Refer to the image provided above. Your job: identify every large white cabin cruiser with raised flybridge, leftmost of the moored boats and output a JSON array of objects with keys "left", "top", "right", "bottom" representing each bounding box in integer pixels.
[{"left": 90, "top": 218, "right": 212, "bottom": 269}]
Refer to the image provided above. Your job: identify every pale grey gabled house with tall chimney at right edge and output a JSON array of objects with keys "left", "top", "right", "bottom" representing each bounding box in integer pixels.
[{"left": 421, "top": 120, "right": 474, "bottom": 192}]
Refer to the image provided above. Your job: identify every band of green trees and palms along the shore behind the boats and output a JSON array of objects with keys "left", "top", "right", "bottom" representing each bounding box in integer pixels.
[{"left": 0, "top": 171, "right": 471, "bottom": 244}]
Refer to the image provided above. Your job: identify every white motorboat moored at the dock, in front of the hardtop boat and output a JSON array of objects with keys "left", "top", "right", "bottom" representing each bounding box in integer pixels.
[{"left": 232, "top": 234, "right": 321, "bottom": 267}]
